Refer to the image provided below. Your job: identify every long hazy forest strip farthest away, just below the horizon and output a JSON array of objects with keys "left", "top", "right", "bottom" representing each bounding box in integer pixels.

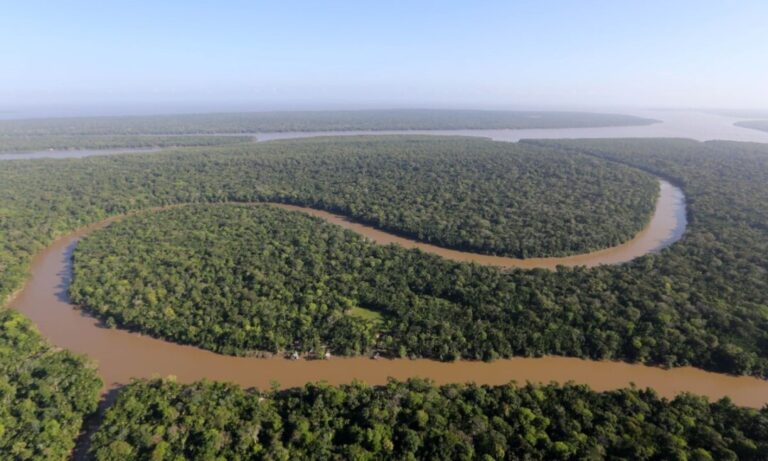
[{"left": 0, "top": 109, "right": 656, "bottom": 135}]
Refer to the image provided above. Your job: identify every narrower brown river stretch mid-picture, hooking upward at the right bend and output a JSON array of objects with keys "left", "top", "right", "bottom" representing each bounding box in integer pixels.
[{"left": 273, "top": 180, "right": 687, "bottom": 269}]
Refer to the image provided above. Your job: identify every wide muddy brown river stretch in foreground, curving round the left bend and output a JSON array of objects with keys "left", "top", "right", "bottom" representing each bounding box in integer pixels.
[{"left": 10, "top": 207, "right": 768, "bottom": 407}]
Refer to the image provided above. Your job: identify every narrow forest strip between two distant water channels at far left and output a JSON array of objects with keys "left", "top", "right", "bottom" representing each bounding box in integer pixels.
[{"left": 0, "top": 135, "right": 253, "bottom": 154}]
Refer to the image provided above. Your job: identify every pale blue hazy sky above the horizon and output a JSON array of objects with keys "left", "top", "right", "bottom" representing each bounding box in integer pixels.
[{"left": 0, "top": 0, "right": 768, "bottom": 113}]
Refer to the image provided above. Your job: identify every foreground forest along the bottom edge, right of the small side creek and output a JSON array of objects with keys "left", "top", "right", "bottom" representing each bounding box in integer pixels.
[{"left": 91, "top": 380, "right": 768, "bottom": 461}]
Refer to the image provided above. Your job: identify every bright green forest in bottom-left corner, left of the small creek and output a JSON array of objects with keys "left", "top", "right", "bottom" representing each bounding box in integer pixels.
[{"left": 0, "top": 309, "right": 101, "bottom": 460}]
